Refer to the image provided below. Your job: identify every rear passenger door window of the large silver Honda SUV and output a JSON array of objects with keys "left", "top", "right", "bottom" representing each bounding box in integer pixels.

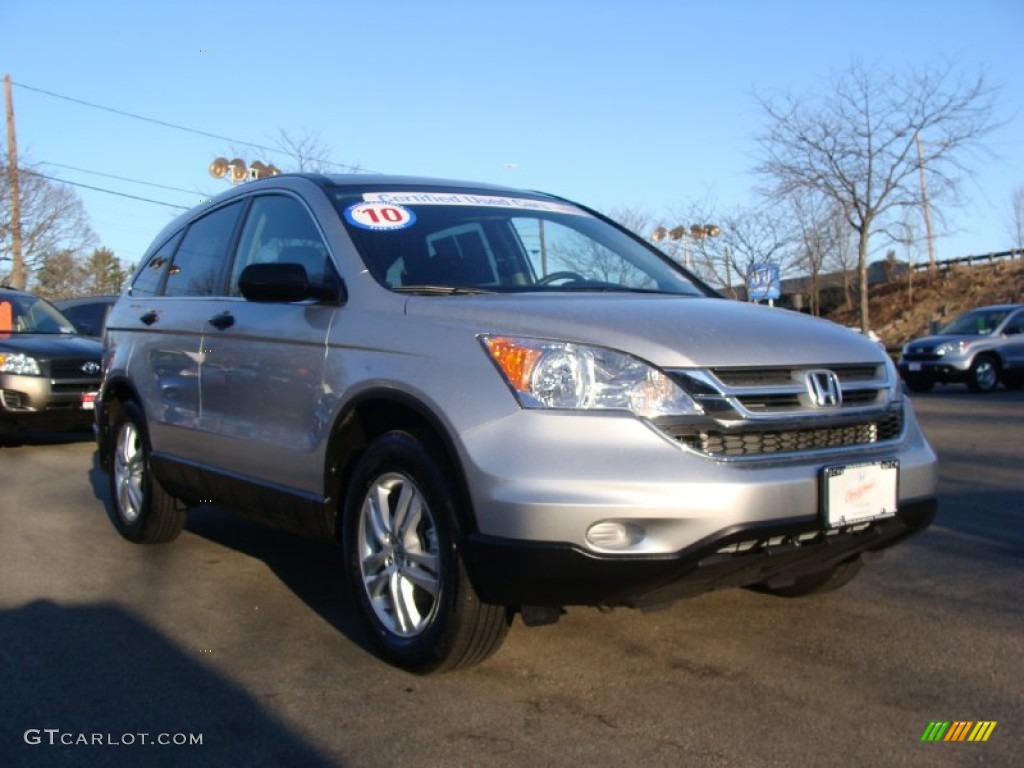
[{"left": 164, "top": 201, "right": 242, "bottom": 296}]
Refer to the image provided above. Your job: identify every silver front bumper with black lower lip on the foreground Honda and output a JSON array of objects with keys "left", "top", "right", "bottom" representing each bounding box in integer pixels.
[{"left": 456, "top": 406, "right": 937, "bottom": 607}]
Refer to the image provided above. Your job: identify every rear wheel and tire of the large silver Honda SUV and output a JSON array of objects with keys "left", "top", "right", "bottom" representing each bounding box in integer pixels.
[{"left": 108, "top": 400, "right": 186, "bottom": 544}]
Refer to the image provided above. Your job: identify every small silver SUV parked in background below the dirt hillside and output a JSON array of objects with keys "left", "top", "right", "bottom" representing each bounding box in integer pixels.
[{"left": 899, "top": 304, "right": 1024, "bottom": 392}]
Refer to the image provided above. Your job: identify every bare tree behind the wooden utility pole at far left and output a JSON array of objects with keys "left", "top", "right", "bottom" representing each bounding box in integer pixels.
[{"left": 0, "top": 165, "right": 96, "bottom": 283}]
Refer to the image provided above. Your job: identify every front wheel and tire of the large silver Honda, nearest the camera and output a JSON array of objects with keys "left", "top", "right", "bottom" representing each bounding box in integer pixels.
[{"left": 343, "top": 431, "right": 510, "bottom": 674}]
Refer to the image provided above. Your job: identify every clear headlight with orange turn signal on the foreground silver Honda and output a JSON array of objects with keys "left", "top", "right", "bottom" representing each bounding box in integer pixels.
[{"left": 481, "top": 336, "right": 701, "bottom": 418}]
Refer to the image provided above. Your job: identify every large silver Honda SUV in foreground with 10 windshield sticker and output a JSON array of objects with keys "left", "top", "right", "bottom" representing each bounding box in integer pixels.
[{"left": 96, "top": 175, "right": 936, "bottom": 672}]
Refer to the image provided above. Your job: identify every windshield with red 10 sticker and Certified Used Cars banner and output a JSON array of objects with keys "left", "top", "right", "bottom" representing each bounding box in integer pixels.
[{"left": 334, "top": 187, "right": 706, "bottom": 296}]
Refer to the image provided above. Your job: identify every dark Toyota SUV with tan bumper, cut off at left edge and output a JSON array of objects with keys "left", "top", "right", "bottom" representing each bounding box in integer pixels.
[{"left": 0, "top": 288, "right": 103, "bottom": 431}]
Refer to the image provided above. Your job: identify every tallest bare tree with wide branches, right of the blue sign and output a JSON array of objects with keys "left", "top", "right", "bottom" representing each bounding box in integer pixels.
[{"left": 757, "top": 62, "right": 996, "bottom": 331}]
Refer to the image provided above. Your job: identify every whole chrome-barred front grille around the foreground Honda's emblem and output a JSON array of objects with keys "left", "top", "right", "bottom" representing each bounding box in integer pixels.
[{"left": 654, "top": 362, "right": 903, "bottom": 459}]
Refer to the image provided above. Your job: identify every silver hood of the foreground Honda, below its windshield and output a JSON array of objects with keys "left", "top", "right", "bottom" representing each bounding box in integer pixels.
[{"left": 406, "top": 293, "right": 886, "bottom": 368}]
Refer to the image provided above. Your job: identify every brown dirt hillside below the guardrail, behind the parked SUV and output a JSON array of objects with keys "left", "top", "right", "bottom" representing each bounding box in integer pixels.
[{"left": 828, "top": 259, "right": 1024, "bottom": 349}]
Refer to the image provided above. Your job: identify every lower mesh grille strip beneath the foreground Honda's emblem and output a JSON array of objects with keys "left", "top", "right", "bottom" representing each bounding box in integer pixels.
[{"left": 662, "top": 409, "right": 903, "bottom": 457}]
